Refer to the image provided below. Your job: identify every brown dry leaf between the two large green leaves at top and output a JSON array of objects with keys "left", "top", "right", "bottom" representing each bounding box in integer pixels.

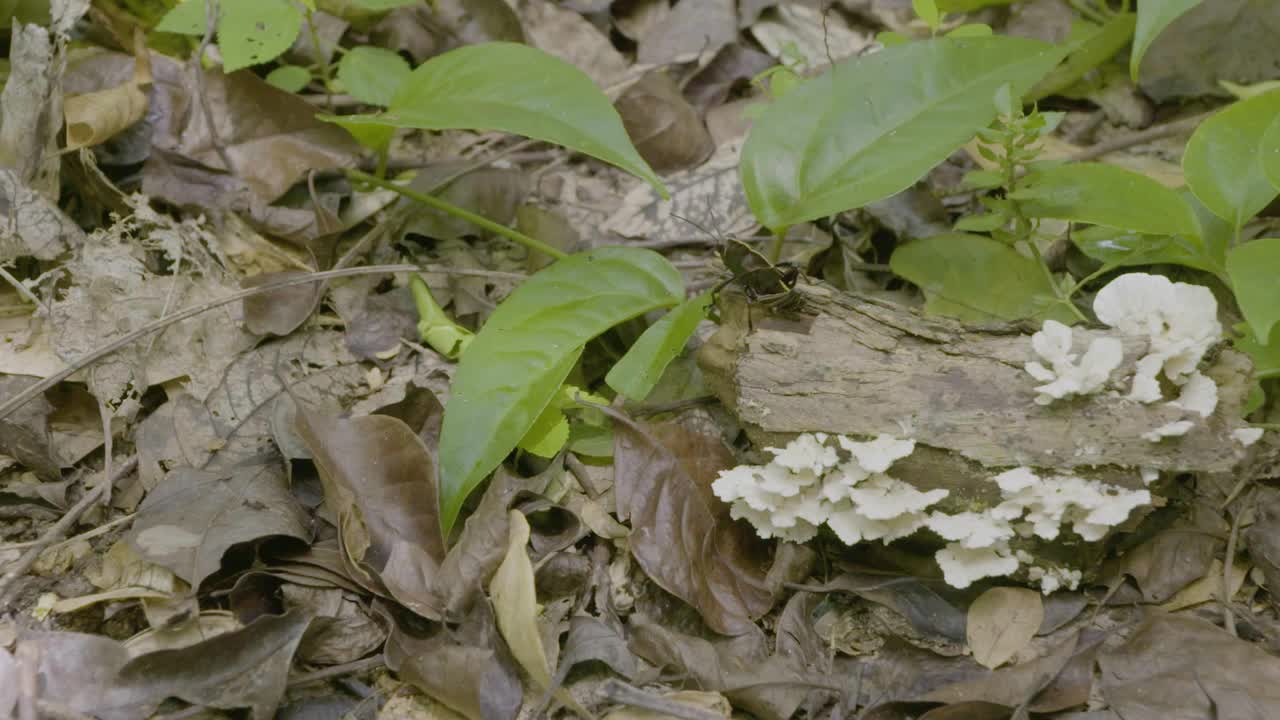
[{"left": 613, "top": 70, "right": 716, "bottom": 174}]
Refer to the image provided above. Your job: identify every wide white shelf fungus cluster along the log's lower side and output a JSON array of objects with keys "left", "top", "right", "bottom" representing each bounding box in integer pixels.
[{"left": 712, "top": 433, "right": 1151, "bottom": 592}]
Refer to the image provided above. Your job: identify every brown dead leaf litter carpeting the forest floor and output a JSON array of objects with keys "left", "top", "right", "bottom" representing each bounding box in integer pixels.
[{"left": 0, "top": 0, "right": 1280, "bottom": 720}]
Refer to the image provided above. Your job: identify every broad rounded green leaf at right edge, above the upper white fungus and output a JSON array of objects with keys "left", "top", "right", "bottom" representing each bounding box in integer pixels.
[{"left": 1183, "top": 90, "right": 1280, "bottom": 228}]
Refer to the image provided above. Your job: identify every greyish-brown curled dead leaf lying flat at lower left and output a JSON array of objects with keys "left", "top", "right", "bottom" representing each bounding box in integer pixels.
[{"left": 128, "top": 457, "right": 311, "bottom": 588}]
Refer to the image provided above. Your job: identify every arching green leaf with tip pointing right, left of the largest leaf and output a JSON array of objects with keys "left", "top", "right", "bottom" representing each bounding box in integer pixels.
[{"left": 321, "top": 42, "right": 667, "bottom": 197}]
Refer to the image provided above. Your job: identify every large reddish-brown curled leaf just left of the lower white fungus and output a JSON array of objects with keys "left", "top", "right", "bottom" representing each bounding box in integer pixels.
[{"left": 613, "top": 415, "right": 773, "bottom": 635}]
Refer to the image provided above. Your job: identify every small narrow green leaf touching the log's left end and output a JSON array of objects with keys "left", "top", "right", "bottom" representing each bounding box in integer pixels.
[{"left": 604, "top": 291, "right": 713, "bottom": 402}]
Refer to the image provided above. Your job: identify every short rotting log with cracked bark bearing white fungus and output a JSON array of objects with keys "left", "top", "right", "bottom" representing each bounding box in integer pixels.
[{"left": 699, "top": 284, "right": 1251, "bottom": 500}]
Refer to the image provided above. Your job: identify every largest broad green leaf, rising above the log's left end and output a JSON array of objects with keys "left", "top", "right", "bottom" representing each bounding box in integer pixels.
[{"left": 740, "top": 36, "right": 1061, "bottom": 231}]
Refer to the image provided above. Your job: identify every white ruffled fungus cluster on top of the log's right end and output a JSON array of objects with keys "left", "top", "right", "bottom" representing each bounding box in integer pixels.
[{"left": 1025, "top": 273, "right": 1222, "bottom": 442}]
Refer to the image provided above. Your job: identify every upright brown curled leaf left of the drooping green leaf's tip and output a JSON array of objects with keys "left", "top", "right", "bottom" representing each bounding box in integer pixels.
[{"left": 294, "top": 407, "right": 445, "bottom": 619}]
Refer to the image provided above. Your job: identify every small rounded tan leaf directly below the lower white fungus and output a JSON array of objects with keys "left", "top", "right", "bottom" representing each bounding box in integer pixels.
[{"left": 965, "top": 588, "right": 1044, "bottom": 670}]
